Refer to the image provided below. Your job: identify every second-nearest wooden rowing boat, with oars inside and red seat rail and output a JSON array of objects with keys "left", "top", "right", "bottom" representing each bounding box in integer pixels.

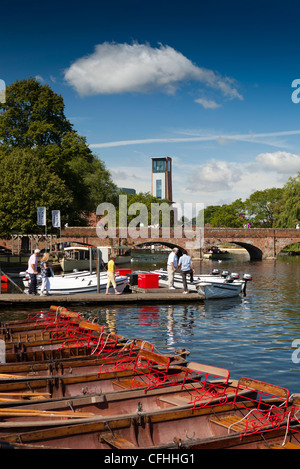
[{"left": 0, "top": 363, "right": 243, "bottom": 433}]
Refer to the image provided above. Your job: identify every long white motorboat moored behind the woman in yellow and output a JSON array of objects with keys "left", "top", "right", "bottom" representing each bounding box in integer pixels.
[{"left": 23, "top": 271, "right": 128, "bottom": 295}]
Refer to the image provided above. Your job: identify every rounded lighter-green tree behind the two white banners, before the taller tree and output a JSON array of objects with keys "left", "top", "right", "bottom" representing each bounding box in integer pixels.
[{"left": 0, "top": 149, "right": 73, "bottom": 237}]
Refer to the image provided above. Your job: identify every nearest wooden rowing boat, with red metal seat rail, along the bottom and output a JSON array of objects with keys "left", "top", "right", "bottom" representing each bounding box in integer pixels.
[{"left": 0, "top": 378, "right": 296, "bottom": 450}]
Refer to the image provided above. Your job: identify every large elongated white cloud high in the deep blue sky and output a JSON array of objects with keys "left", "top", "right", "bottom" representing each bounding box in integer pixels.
[{"left": 65, "top": 42, "right": 243, "bottom": 99}]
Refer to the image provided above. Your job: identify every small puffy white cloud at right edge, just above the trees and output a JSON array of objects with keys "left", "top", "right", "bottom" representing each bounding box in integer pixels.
[{"left": 256, "top": 151, "right": 300, "bottom": 174}]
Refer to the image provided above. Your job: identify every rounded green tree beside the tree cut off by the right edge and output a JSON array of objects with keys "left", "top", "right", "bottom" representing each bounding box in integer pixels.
[{"left": 245, "top": 187, "right": 282, "bottom": 227}]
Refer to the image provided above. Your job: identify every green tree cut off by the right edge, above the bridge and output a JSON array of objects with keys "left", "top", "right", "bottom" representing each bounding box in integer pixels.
[{"left": 275, "top": 172, "right": 300, "bottom": 228}]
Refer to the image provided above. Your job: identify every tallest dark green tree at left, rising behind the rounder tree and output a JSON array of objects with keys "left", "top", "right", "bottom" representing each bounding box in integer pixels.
[{"left": 0, "top": 78, "right": 117, "bottom": 225}]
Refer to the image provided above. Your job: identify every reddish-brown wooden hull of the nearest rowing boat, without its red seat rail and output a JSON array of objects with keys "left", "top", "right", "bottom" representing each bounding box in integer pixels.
[{"left": 0, "top": 394, "right": 292, "bottom": 450}]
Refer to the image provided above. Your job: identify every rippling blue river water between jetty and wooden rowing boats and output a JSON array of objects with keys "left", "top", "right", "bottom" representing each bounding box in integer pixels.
[{"left": 1, "top": 253, "right": 300, "bottom": 393}]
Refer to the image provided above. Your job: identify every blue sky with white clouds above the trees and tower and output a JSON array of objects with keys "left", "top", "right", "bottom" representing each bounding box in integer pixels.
[{"left": 0, "top": 0, "right": 300, "bottom": 212}]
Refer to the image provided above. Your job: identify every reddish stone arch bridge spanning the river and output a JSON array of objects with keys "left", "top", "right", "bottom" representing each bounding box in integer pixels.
[{"left": 61, "top": 227, "right": 300, "bottom": 260}]
